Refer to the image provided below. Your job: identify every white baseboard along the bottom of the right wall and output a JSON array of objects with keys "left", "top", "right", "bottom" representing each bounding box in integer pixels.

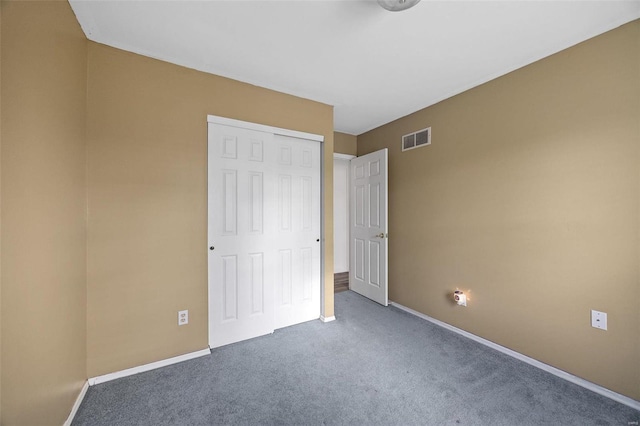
[{"left": 389, "top": 301, "right": 640, "bottom": 411}]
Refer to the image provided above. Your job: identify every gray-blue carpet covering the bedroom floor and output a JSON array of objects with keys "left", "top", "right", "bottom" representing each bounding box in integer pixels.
[{"left": 73, "top": 291, "right": 640, "bottom": 426}]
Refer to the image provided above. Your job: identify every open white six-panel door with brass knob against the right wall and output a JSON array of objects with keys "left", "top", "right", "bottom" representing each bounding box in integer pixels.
[{"left": 349, "top": 148, "right": 389, "bottom": 306}]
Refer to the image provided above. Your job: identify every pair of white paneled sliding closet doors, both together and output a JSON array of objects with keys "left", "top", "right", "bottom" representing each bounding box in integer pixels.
[{"left": 208, "top": 123, "right": 321, "bottom": 348}]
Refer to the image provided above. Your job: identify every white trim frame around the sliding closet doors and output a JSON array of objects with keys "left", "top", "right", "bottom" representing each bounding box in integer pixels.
[{"left": 205, "top": 115, "right": 325, "bottom": 343}]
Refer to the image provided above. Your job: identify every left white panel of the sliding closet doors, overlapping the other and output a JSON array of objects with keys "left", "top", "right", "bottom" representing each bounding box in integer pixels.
[{"left": 208, "top": 124, "right": 276, "bottom": 347}]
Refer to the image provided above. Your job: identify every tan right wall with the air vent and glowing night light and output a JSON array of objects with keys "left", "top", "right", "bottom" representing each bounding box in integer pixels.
[{"left": 358, "top": 21, "right": 640, "bottom": 400}]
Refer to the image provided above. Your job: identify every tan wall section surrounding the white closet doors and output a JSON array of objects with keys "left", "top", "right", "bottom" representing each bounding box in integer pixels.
[{"left": 88, "top": 43, "right": 333, "bottom": 377}]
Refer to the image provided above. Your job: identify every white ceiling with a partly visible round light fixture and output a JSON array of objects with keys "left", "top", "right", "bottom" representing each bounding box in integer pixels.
[{"left": 70, "top": 0, "right": 640, "bottom": 135}]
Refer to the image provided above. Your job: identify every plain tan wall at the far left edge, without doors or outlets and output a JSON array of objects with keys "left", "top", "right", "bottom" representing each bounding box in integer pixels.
[{"left": 0, "top": 1, "right": 87, "bottom": 425}]
